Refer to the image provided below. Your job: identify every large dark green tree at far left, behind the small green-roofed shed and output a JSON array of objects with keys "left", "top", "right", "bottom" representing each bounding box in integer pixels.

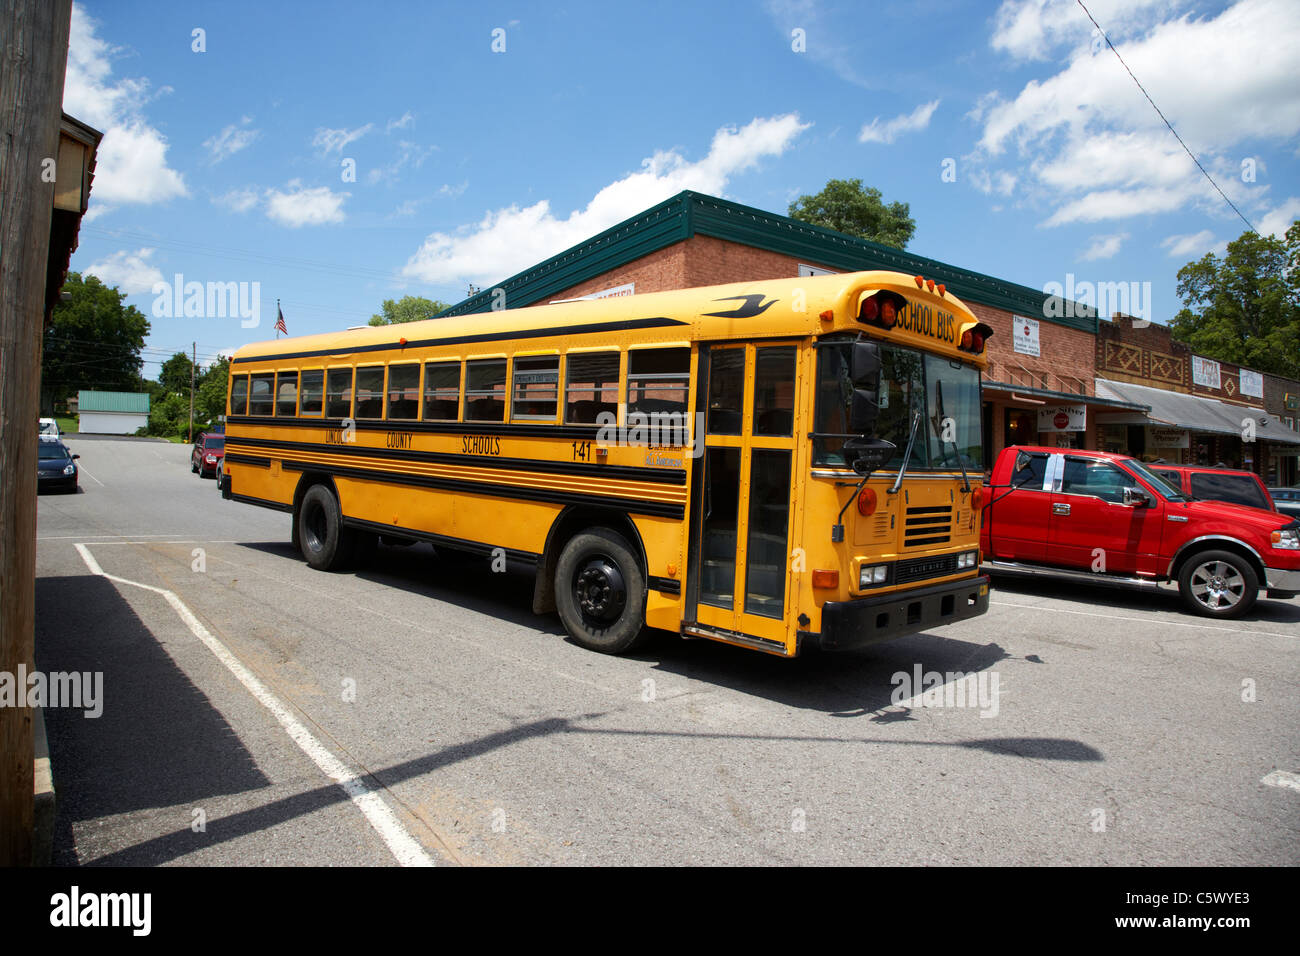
[{"left": 40, "top": 272, "right": 150, "bottom": 414}]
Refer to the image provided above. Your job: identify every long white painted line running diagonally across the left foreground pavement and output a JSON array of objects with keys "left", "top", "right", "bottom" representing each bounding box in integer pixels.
[{"left": 77, "top": 542, "right": 433, "bottom": 866}]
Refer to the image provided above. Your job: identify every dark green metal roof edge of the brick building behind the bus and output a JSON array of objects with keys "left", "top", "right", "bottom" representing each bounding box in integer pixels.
[{"left": 439, "top": 190, "right": 1097, "bottom": 334}]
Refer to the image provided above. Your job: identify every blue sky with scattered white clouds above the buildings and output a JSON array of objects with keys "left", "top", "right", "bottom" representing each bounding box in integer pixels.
[{"left": 64, "top": 0, "right": 1300, "bottom": 377}]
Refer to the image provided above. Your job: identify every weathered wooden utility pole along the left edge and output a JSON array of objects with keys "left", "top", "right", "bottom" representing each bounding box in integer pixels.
[{"left": 0, "top": 0, "right": 72, "bottom": 866}]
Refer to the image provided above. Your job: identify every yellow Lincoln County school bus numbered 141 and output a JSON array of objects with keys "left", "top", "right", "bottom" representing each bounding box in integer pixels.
[{"left": 222, "top": 272, "right": 991, "bottom": 657}]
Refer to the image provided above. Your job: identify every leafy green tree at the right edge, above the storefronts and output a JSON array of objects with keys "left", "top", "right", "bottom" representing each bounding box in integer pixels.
[{"left": 1169, "top": 222, "right": 1300, "bottom": 378}]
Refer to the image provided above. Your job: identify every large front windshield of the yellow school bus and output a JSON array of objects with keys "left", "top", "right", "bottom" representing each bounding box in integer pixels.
[{"left": 813, "top": 342, "right": 984, "bottom": 473}]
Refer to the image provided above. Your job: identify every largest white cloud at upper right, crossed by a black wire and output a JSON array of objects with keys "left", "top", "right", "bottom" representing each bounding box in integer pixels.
[{"left": 967, "top": 0, "right": 1300, "bottom": 225}]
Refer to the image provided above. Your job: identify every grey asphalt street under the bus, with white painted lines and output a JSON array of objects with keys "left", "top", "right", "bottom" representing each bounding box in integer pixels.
[{"left": 36, "top": 436, "right": 1300, "bottom": 866}]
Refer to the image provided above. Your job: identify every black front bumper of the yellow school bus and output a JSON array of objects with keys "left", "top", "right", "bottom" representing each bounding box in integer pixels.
[{"left": 800, "top": 575, "right": 989, "bottom": 650}]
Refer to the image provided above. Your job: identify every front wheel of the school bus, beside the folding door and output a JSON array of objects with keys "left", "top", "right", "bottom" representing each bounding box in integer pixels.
[{"left": 555, "top": 528, "right": 647, "bottom": 654}]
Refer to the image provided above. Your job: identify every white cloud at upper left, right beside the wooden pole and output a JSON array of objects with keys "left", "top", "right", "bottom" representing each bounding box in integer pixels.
[{"left": 64, "top": 7, "right": 190, "bottom": 203}]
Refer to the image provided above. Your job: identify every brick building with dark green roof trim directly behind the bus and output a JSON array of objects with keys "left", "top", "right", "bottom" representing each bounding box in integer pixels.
[{"left": 443, "top": 191, "right": 1147, "bottom": 462}]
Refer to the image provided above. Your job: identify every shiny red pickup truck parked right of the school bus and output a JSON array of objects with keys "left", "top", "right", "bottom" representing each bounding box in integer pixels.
[{"left": 980, "top": 446, "right": 1300, "bottom": 618}]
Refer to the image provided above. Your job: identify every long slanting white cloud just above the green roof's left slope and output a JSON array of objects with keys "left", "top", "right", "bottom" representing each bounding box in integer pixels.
[{"left": 402, "top": 113, "right": 810, "bottom": 284}]
